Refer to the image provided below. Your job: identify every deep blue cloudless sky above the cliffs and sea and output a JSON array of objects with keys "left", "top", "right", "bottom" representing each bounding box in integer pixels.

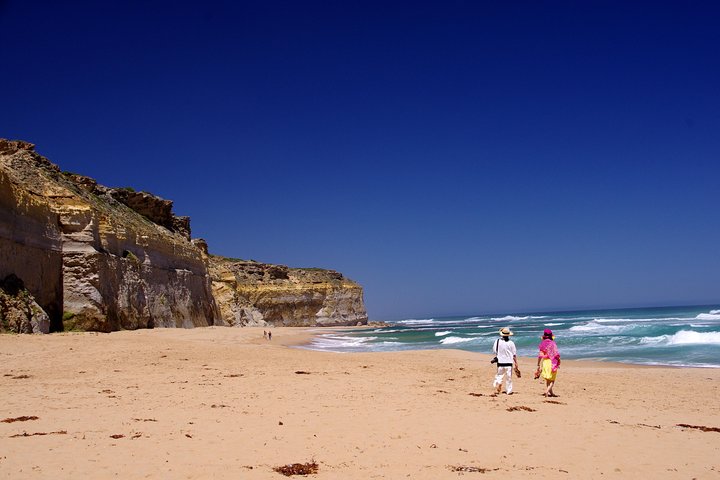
[{"left": 0, "top": 0, "right": 720, "bottom": 320}]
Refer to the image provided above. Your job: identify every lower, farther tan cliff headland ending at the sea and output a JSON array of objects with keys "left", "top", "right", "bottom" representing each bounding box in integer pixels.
[{"left": 210, "top": 256, "right": 367, "bottom": 326}]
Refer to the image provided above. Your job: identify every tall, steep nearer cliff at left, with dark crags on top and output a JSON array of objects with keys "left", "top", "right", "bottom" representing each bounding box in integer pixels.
[{"left": 0, "top": 140, "right": 219, "bottom": 331}]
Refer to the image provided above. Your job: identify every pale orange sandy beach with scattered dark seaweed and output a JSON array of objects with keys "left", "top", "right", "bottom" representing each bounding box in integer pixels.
[{"left": 0, "top": 327, "right": 720, "bottom": 479}]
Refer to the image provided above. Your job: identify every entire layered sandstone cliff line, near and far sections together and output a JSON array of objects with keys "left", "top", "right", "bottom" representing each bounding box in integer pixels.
[{"left": 0, "top": 139, "right": 367, "bottom": 333}]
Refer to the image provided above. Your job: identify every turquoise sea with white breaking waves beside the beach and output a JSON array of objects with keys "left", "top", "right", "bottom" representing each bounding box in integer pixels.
[{"left": 308, "top": 305, "right": 720, "bottom": 368}]
